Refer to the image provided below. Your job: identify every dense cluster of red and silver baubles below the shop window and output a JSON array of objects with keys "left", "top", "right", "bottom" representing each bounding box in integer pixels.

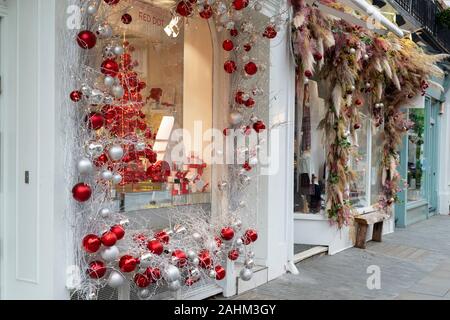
[{"left": 82, "top": 220, "right": 258, "bottom": 298}]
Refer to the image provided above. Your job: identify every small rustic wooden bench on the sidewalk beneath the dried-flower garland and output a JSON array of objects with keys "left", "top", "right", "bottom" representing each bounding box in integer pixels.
[{"left": 355, "top": 212, "right": 387, "bottom": 249}]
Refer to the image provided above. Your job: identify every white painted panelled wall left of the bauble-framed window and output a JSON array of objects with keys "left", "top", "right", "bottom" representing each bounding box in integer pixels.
[{"left": 1, "top": 0, "right": 67, "bottom": 299}]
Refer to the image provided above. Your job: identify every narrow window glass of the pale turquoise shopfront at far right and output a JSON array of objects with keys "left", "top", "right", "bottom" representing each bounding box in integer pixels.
[{"left": 408, "top": 109, "right": 425, "bottom": 202}]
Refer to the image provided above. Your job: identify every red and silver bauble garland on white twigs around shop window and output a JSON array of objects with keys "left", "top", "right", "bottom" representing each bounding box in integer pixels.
[{"left": 67, "top": 0, "right": 278, "bottom": 299}]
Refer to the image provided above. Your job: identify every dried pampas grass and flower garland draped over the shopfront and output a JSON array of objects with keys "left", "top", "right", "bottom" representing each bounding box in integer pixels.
[{"left": 292, "top": 0, "right": 447, "bottom": 227}]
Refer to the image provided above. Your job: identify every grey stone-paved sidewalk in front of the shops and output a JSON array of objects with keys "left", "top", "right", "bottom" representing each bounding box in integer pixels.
[{"left": 235, "top": 216, "right": 450, "bottom": 300}]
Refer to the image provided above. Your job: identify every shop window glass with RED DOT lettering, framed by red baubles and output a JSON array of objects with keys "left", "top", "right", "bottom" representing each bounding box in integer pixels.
[{"left": 97, "top": 0, "right": 213, "bottom": 211}]
